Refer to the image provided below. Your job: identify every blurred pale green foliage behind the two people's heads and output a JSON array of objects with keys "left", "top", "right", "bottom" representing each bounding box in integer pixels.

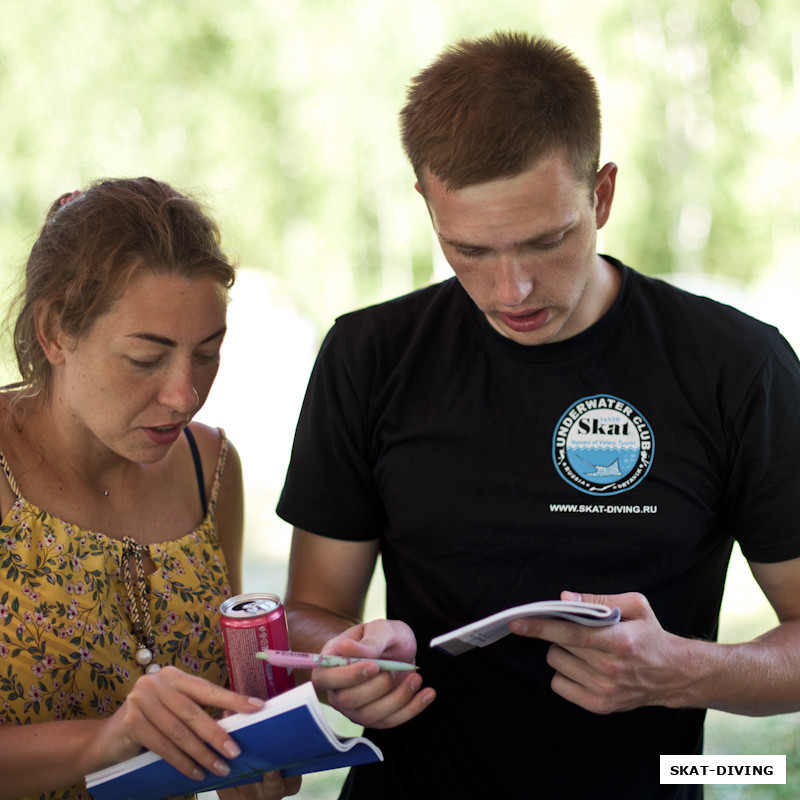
[{"left": 0, "top": 0, "right": 800, "bottom": 346}]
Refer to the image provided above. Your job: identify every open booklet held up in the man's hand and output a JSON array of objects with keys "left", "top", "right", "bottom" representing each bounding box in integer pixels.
[{"left": 431, "top": 600, "right": 620, "bottom": 656}]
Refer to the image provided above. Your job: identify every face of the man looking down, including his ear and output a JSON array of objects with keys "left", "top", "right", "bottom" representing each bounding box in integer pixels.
[{"left": 418, "top": 153, "right": 619, "bottom": 345}]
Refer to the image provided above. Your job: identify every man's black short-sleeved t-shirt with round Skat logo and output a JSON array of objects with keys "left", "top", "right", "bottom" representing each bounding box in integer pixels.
[{"left": 278, "top": 258, "right": 800, "bottom": 800}]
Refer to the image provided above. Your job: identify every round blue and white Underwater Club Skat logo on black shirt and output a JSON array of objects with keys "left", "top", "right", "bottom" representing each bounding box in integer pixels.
[{"left": 553, "top": 394, "right": 655, "bottom": 495}]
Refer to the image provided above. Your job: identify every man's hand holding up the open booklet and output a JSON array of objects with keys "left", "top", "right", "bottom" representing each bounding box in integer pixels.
[{"left": 509, "top": 592, "right": 691, "bottom": 714}]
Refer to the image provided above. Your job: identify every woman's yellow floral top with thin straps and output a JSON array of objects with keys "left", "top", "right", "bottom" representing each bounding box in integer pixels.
[{"left": 0, "top": 434, "right": 230, "bottom": 800}]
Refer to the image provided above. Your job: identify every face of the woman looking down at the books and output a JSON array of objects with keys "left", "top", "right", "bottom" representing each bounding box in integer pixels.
[{"left": 50, "top": 271, "right": 227, "bottom": 463}]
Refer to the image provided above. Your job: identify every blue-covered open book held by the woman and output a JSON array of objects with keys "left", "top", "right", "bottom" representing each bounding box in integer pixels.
[{"left": 86, "top": 683, "right": 383, "bottom": 800}]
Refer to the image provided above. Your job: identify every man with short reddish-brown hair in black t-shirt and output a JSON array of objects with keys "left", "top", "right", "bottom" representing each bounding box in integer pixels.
[{"left": 278, "top": 29, "right": 800, "bottom": 800}]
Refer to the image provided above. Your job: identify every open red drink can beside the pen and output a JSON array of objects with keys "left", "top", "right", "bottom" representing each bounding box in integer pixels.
[{"left": 219, "top": 593, "right": 294, "bottom": 700}]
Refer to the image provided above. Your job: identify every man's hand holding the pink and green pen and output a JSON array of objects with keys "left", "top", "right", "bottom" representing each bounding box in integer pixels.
[{"left": 312, "top": 620, "right": 436, "bottom": 728}]
